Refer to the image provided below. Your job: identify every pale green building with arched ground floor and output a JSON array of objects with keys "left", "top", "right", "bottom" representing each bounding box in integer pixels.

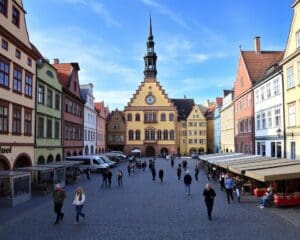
[{"left": 34, "top": 59, "right": 63, "bottom": 164}]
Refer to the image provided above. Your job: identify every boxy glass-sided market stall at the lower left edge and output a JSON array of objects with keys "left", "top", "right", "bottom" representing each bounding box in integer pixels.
[{"left": 0, "top": 171, "right": 31, "bottom": 207}]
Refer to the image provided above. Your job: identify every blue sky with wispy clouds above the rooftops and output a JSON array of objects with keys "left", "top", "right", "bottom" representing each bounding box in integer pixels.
[{"left": 23, "top": 0, "right": 293, "bottom": 110}]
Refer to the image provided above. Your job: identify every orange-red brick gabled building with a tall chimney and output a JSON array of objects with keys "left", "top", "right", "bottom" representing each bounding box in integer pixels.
[{"left": 234, "top": 37, "right": 283, "bottom": 153}]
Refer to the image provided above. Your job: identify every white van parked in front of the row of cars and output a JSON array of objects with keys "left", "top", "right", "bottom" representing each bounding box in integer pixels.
[{"left": 66, "top": 155, "right": 109, "bottom": 173}]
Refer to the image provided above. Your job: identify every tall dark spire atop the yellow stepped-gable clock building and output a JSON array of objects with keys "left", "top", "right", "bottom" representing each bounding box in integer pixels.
[{"left": 144, "top": 15, "right": 157, "bottom": 78}]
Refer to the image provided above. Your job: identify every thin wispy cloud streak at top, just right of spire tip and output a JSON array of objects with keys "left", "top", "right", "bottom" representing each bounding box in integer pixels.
[{"left": 141, "top": 0, "right": 189, "bottom": 28}]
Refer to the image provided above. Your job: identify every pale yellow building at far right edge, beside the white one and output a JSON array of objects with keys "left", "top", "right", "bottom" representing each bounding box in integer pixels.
[{"left": 281, "top": 0, "right": 300, "bottom": 159}]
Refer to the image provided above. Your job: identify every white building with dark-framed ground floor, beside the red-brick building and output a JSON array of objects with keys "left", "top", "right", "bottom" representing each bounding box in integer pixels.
[{"left": 254, "top": 67, "right": 285, "bottom": 158}]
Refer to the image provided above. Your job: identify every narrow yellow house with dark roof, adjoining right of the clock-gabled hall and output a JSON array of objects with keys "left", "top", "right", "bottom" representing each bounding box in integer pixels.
[{"left": 171, "top": 98, "right": 195, "bottom": 155}]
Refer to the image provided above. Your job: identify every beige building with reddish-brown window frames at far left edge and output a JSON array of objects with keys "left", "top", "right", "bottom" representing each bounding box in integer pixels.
[{"left": 0, "top": 0, "right": 42, "bottom": 170}]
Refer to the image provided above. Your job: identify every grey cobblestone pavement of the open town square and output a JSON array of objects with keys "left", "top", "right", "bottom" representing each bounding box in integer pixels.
[{"left": 0, "top": 159, "right": 300, "bottom": 240}]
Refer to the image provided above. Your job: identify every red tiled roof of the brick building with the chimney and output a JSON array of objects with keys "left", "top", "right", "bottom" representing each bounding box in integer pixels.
[{"left": 241, "top": 51, "right": 284, "bottom": 82}]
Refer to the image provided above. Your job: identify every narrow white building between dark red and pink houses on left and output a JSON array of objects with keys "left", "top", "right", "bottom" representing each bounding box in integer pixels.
[{"left": 80, "top": 83, "right": 97, "bottom": 155}]
